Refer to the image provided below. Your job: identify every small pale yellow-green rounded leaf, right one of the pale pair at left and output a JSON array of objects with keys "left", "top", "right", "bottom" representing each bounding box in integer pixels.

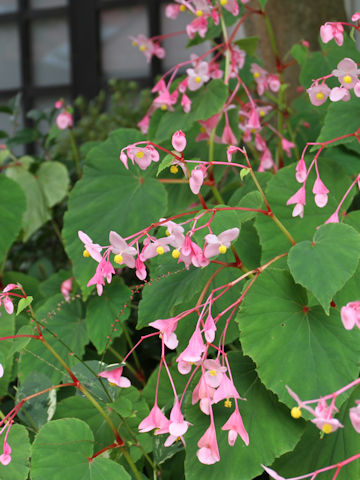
[{"left": 36, "top": 162, "right": 70, "bottom": 208}]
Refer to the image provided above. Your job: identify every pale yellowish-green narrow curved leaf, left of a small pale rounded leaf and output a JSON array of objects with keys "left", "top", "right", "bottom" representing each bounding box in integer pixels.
[{"left": 6, "top": 166, "right": 51, "bottom": 241}]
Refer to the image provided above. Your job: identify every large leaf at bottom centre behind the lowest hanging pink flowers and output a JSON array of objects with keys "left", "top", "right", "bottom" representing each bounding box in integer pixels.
[{"left": 185, "top": 353, "right": 303, "bottom": 480}]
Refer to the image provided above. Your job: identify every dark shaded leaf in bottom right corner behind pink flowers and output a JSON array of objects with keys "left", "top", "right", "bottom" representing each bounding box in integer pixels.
[{"left": 272, "top": 388, "right": 360, "bottom": 480}]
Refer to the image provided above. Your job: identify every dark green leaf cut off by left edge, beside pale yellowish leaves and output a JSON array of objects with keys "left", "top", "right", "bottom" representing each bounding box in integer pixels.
[{"left": 0, "top": 175, "right": 26, "bottom": 259}]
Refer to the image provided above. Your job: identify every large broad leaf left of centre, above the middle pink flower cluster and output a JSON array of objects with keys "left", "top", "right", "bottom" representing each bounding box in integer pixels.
[{"left": 63, "top": 129, "right": 167, "bottom": 295}]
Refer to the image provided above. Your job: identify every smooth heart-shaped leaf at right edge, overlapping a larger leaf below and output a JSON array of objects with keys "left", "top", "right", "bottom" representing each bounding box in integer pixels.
[{"left": 288, "top": 223, "right": 360, "bottom": 313}]
